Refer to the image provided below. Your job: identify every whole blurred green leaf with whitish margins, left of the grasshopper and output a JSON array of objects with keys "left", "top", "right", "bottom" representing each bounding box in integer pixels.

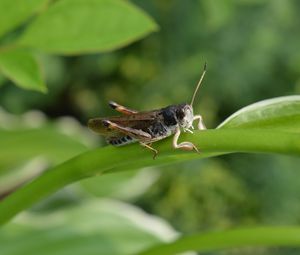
[{"left": 0, "top": 110, "right": 89, "bottom": 196}]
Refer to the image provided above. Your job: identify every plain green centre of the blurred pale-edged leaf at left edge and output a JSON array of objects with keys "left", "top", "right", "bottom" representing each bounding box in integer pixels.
[{"left": 0, "top": 126, "right": 87, "bottom": 172}]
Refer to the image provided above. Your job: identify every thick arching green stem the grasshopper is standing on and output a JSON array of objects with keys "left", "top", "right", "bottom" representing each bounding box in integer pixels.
[{"left": 0, "top": 97, "right": 300, "bottom": 224}]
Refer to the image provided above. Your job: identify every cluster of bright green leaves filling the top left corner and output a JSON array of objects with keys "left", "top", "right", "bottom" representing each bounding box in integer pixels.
[{"left": 0, "top": 0, "right": 157, "bottom": 92}]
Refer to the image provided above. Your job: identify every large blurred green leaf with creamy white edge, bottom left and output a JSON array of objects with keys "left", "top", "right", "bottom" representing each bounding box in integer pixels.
[{"left": 0, "top": 200, "right": 177, "bottom": 255}]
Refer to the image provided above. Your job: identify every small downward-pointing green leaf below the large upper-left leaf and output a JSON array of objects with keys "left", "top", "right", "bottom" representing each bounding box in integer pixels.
[{"left": 0, "top": 49, "right": 47, "bottom": 92}]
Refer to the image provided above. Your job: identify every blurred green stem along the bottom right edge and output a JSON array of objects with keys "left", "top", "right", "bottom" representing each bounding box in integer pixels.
[{"left": 138, "top": 227, "right": 300, "bottom": 255}]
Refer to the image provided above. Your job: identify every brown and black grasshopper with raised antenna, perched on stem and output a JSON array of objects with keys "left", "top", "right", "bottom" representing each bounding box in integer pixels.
[{"left": 88, "top": 64, "right": 206, "bottom": 159}]
